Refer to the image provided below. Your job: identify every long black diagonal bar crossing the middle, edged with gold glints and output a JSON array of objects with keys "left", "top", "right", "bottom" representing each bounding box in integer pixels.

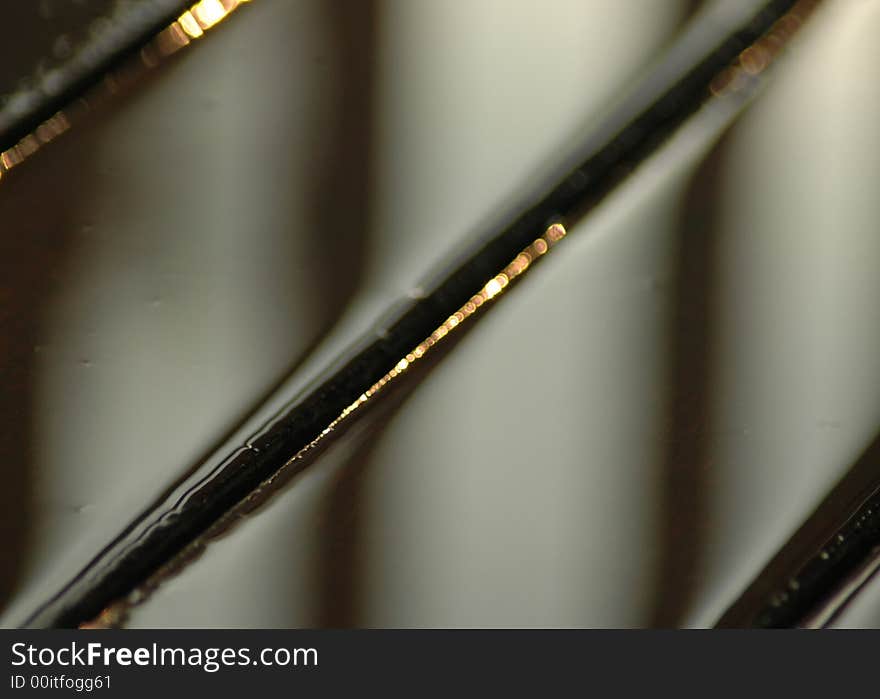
[{"left": 20, "top": 0, "right": 814, "bottom": 626}]
